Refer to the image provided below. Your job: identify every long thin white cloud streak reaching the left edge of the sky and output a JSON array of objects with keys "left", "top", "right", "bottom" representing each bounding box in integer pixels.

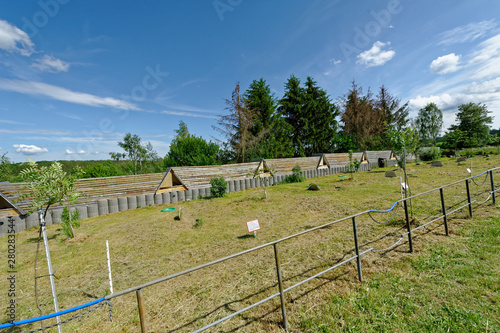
[{"left": 0, "top": 79, "right": 140, "bottom": 111}]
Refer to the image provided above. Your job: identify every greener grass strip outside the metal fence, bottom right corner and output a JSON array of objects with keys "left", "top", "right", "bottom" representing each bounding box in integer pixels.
[{"left": 297, "top": 217, "right": 500, "bottom": 332}]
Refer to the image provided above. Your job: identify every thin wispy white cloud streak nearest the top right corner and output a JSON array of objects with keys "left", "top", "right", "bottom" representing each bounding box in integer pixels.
[{"left": 437, "top": 20, "right": 497, "bottom": 45}]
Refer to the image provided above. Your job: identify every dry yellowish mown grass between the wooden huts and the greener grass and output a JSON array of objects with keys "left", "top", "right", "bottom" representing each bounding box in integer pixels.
[{"left": 0, "top": 155, "right": 500, "bottom": 332}]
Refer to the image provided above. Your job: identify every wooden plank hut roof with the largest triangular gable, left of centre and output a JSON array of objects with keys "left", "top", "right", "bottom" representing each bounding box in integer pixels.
[{"left": 155, "top": 160, "right": 268, "bottom": 193}]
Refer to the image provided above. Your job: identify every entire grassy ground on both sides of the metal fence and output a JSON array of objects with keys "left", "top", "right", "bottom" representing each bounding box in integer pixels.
[{"left": 0, "top": 155, "right": 500, "bottom": 332}]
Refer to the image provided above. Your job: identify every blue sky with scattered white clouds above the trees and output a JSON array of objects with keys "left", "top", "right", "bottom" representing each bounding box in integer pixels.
[{"left": 0, "top": 0, "right": 500, "bottom": 162}]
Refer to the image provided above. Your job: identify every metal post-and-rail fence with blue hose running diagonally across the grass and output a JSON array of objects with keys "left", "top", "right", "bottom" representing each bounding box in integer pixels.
[{"left": 0, "top": 167, "right": 500, "bottom": 333}]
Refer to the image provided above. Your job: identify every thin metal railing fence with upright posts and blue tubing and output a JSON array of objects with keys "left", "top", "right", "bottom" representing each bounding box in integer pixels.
[{"left": 0, "top": 167, "right": 500, "bottom": 332}]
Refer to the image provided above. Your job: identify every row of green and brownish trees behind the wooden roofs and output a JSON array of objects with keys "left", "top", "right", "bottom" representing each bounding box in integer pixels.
[{"left": 0, "top": 75, "right": 500, "bottom": 181}]
